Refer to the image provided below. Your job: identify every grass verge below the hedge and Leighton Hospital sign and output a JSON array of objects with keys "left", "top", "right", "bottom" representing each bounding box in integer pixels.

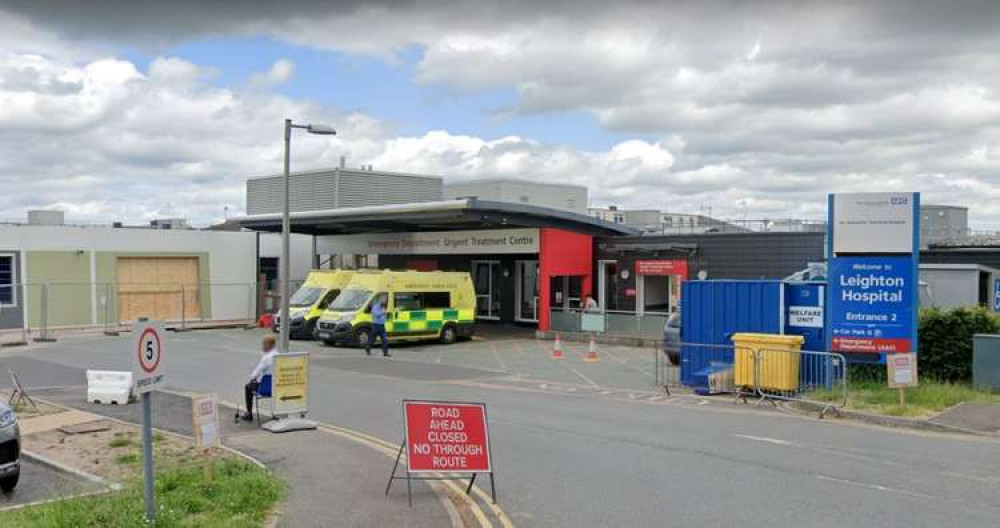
[{"left": 812, "top": 380, "right": 1000, "bottom": 417}]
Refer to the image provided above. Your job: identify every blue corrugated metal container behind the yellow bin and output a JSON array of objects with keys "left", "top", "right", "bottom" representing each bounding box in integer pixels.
[{"left": 681, "top": 280, "right": 783, "bottom": 385}]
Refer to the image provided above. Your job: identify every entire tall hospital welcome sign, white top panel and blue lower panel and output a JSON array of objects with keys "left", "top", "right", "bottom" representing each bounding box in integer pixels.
[{"left": 826, "top": 193, "right": 920, "bottom": 364}]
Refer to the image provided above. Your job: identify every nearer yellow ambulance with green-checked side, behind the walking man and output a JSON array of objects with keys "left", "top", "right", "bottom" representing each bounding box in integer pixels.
[{"left": 316, "top": 270, "right": 476, "bottom": 346}]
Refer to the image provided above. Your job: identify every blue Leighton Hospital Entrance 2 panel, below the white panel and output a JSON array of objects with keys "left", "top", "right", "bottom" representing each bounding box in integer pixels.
[{"left": 829, "top": 256, "right": 916, "bottom": 354}]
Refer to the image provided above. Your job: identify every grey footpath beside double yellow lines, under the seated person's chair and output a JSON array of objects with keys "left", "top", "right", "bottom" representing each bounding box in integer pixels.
[{"left": 33, "top": 387, "right": 471, "bottom": 527}]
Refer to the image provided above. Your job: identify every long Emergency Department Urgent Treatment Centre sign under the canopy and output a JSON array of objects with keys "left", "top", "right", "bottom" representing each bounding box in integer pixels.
[{"left": 316, "top": 229, "right": 540, "bottom": 255}]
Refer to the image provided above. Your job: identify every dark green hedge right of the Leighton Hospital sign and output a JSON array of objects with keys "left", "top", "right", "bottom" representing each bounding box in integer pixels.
[{"left": 918, "top": 308, "right": 1000, "bottom": 382}]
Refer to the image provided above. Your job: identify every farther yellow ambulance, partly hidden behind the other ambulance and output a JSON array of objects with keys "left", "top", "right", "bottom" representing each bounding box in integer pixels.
[{"left": 272, "top": 269, "right": 355, "bottom": 339}]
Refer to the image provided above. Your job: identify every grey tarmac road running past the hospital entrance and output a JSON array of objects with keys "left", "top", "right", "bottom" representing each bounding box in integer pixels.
[{"left": 0, "top": 330, "right": 1000, "bottom": 528}]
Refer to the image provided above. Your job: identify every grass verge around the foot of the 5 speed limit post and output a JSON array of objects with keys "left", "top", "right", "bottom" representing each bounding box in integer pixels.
[{"left": 0, "top": 459, "right": 285, "bottom": 528}]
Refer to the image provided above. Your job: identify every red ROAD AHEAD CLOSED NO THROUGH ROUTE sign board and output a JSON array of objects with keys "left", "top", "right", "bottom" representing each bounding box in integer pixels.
[{"left": 403, "top": 401, "right": 492, "bottom": 473}]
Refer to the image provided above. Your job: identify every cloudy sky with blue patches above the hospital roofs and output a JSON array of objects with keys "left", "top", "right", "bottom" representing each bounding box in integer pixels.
[{"left": 0, "top": 0, "right": 1000, "bottom": 229}]
